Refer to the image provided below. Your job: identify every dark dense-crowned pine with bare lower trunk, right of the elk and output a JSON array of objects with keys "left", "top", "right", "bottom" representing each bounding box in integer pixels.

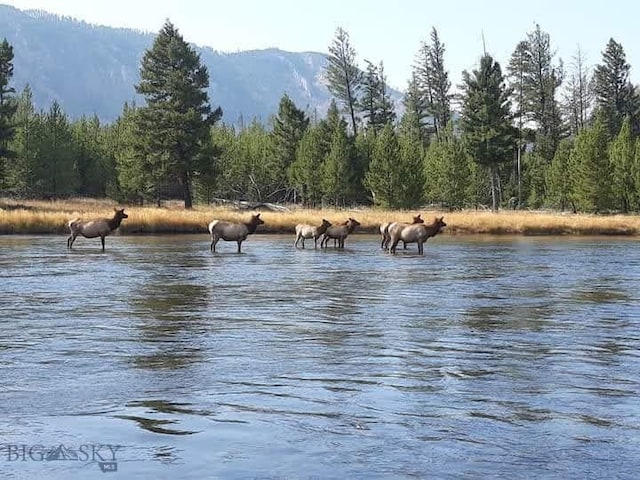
[{"left": 460, "top": 55, "right": 515, "bottom": 210}]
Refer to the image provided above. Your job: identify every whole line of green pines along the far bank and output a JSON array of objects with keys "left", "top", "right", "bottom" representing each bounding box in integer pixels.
[{"left": 0, "top": 22, "right": 640, "bottom": 212}]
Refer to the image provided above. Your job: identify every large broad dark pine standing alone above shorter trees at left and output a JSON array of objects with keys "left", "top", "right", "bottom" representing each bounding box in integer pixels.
[{"left": 136, "top": 21, "right": 222, "bottom": 208}]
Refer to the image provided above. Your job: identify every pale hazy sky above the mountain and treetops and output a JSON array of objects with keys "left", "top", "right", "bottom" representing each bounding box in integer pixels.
[{"left": 0, "top": 0, "right": 640, "bottom": 89}]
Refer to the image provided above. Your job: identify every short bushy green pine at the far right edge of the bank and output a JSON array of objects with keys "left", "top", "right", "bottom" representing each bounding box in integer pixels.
[{"left": 609, "top": 116, "right": 638, "bottom": 213}]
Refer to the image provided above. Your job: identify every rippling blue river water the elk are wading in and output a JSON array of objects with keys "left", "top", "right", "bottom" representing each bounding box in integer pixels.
[{"left": 0, "top": 235, "right": 640, "bottom": 479}]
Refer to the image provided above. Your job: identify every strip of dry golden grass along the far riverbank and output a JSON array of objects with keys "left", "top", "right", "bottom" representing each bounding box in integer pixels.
[{"left": 0, "top": 199, "right": 640, "bottom": 235}]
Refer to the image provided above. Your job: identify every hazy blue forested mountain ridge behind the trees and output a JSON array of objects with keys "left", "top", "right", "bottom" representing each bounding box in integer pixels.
[{"left": 0, "top": 5, "right": 400, "bottom": 124}]
